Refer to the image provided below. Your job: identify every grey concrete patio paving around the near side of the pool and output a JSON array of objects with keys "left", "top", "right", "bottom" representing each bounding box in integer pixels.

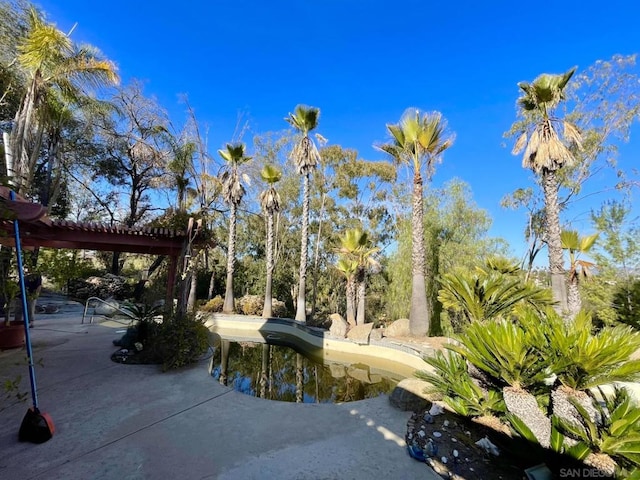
[{"left": 0, "top": 304, "right": 440, "bottom": 480}]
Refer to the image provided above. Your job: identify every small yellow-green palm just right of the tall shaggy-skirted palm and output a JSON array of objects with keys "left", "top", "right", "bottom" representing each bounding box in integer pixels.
[{"left": 560, "top": 230, "right": 598, "bottom": 318}]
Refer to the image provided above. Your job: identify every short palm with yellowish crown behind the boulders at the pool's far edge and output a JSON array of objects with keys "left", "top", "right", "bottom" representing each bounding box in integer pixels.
[{"left": 338, "top": 228, "right": 379, "bottom": 325}]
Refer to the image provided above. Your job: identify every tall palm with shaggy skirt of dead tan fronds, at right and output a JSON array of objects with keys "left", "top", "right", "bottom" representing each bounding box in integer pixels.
[{"left": 513, "top": 67, "right": 582, "bottom": 316}]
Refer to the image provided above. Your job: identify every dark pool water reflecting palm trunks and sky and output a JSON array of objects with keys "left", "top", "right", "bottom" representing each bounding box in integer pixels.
[{"left": 211, "top": 339, "right": 400, "bottom": 403}]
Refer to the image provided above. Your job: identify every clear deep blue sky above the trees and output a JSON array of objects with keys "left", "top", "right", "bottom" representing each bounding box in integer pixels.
[{"left": 33, "top": 0, "right": 640, "bottom": 263}]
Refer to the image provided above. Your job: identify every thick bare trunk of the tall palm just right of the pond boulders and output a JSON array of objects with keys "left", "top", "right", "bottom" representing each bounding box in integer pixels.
[{"left": 409, "top": 172, "right": 430, "bottom": 337}]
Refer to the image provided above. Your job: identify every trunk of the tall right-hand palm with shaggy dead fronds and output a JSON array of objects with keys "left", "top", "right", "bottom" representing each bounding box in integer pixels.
[{"left": 542, "top": 169, "right": 567, "bottom": 313}]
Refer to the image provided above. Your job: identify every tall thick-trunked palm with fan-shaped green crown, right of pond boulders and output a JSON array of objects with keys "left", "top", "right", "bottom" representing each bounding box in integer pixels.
[{"left": 379, "top": 108, "right": 454, "bottom": 336}]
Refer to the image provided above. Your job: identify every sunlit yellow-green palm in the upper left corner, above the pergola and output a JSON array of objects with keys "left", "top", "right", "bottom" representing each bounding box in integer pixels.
[{"left": 9, "top": 8, "right": 118, "bottom": 193}]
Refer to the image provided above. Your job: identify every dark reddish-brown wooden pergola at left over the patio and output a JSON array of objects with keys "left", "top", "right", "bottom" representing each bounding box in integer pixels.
[{"left": 0, "top": 186, "right": 189, "bottom": 305}]
